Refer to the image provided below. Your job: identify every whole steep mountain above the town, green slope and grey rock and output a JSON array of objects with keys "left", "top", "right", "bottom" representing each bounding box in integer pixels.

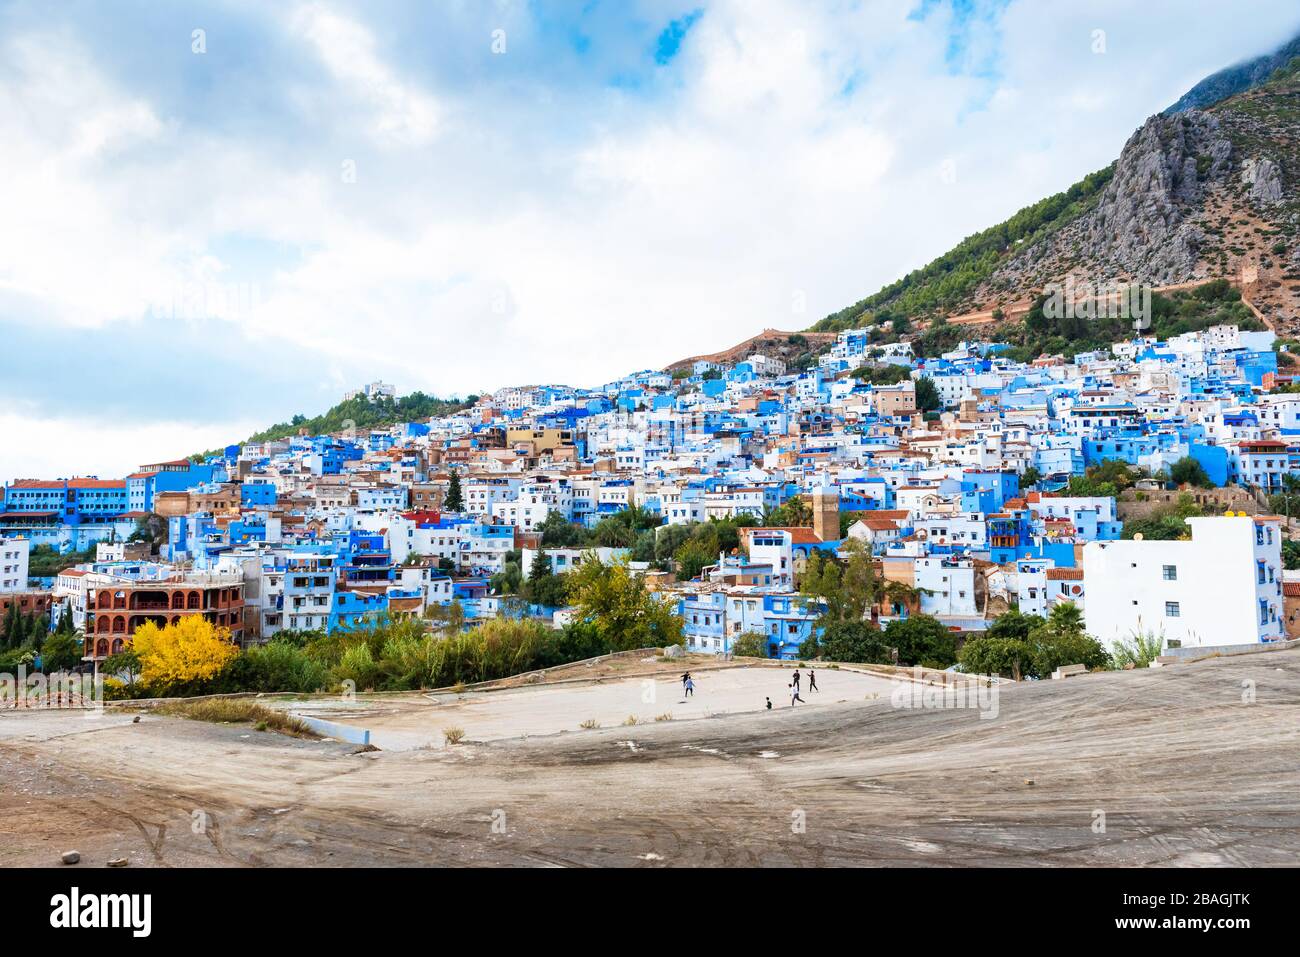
[{"left": 814, "top": 38, "right": 1300, "bottom": 333}]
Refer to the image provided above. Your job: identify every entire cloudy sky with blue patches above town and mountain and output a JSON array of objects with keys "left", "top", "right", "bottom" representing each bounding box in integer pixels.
[{"left": 0, "top": 0, "right": 1300, "bottom": 480}]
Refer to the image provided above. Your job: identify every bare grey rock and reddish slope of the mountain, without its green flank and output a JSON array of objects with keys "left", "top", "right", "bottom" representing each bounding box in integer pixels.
[{"left": 974, "top": 63, "right": 1300, "bottom": 326}]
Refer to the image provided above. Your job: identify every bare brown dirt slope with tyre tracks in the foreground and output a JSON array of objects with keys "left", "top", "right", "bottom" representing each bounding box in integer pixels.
[{"left": 0, "top": 651, "right": 1300, "bottom": 866}]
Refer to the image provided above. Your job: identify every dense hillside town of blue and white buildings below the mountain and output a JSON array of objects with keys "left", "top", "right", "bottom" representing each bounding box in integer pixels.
[{"left": 0, "top": 317, "right": 1300, "bottom": 663}]
